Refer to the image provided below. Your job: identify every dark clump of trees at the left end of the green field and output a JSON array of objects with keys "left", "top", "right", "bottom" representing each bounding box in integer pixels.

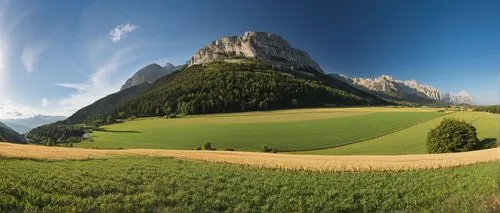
[{"left": 26, "top": 124, "right": 91, "bottom": 146}]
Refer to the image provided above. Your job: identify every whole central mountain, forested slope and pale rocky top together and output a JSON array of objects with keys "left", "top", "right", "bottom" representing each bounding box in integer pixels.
[{"left": 114, "top": 32, "right": 386, "bottom": 117}]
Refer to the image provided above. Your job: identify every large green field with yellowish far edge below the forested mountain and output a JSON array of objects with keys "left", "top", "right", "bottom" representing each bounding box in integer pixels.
[{"left": 77, "top": 108, "right": 443, "bottom": 151}]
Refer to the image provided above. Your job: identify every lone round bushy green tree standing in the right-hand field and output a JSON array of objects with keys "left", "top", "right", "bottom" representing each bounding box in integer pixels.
[{"left": 427, "top": 118, "right": 480, "bottom": 153}]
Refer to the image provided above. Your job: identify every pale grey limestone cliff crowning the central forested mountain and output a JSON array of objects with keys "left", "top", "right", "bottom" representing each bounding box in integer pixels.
[{"left": 188, "top": 31, "right": 323, "bottom": 73}]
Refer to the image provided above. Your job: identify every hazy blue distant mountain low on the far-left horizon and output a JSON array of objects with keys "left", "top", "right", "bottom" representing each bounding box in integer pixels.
[{"left": 1, "top": 115, "right": 66, "bottom": 134}]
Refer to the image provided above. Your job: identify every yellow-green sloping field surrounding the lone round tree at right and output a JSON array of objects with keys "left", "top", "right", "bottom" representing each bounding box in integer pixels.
[{"left": 298, "top": 112, "right": 500, "bottom": 155}]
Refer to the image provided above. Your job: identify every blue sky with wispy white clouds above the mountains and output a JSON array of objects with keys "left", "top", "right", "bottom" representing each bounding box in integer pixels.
[{"left": 0, "top": 0, "right": 500, "bottom": 118}]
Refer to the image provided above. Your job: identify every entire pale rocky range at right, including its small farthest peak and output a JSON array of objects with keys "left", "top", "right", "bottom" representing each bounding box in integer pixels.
[{"left": 331, "top": 74, "right": 472, "bottom": 105}]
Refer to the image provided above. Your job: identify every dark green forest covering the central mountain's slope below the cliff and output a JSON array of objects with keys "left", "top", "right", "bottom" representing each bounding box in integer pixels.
[{"left": 113, "top": 62, "right": 368, "bottom": 118}]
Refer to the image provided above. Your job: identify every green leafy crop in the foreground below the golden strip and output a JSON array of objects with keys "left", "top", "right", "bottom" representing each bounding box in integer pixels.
[{"left": 0, "top": 157, "right": 500, "bottom": 212}]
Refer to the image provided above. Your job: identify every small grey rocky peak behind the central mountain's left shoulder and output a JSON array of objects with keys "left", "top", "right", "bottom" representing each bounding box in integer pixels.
[{"left": 120, "top": 63, "right": 184, "bottom": 90}]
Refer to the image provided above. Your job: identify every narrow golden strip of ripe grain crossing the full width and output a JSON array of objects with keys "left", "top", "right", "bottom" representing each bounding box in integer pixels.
[{"left": 0, "top": 143, "right": 500, "bottom": 172}]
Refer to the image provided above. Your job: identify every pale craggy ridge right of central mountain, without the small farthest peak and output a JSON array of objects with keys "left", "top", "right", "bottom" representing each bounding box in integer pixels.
[{"left": 333, "top": 74, "right": 441, "bottom": 103}]
